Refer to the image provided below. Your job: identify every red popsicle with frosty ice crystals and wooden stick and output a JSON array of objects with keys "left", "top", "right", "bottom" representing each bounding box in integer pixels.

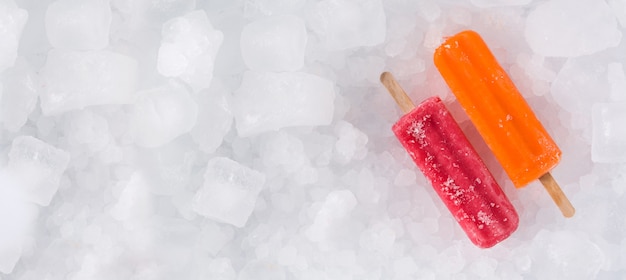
[{"left": 381, "top": 72, "right": 519, "bottom": 248}]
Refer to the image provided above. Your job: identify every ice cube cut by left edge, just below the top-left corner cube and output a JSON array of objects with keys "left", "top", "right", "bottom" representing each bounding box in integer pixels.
[{"left": 0, "top": 58, "right": 41, "bottom": 132}]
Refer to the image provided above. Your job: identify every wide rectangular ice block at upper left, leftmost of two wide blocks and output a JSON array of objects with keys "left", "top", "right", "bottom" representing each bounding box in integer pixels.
[{"left": 41, "top": 49, "right": 137, "bottom": 115}]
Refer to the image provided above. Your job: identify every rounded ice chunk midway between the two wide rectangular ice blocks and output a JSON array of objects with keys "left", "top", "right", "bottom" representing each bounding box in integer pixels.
[{"left": 129, "top": 85, "right": 198, "bottom": 148}]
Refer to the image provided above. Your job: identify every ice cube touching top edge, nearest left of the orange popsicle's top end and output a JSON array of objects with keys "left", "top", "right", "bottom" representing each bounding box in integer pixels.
[{"left": 307, "top": 0, "right": 387, "bottom": 50}]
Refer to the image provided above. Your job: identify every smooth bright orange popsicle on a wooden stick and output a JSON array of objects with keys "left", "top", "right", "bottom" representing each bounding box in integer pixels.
[{"left": 435, "top": 30, "right": 574, "bottom": 217}]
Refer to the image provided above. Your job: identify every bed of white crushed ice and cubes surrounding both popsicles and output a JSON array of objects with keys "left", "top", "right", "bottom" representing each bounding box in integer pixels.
[{"left": 0, "top": 0, "right": 626, "bottom": 280}]
